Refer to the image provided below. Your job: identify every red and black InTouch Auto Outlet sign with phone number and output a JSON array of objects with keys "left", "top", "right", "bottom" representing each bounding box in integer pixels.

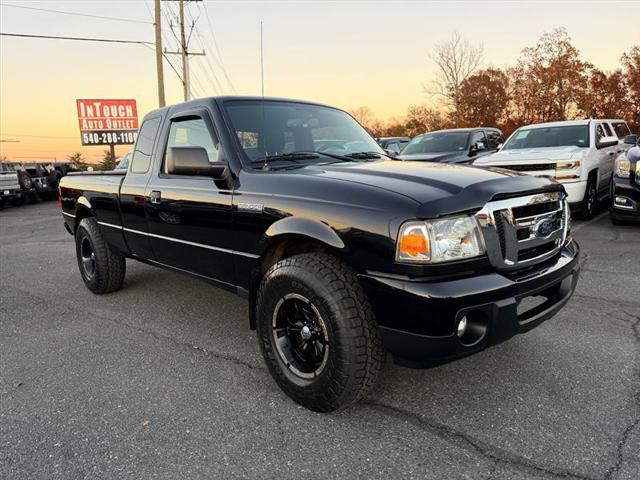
[{"left": 76, "top": 99, "right": 138, "bottom": 145}]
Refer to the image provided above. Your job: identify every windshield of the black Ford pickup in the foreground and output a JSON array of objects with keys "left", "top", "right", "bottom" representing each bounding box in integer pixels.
[{"left": 225, "top": 100, "right": 383, "bottom": 161}]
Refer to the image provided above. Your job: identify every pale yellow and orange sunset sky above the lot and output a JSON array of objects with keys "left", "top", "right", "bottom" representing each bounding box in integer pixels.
[{"left": 0, "top": 0, "right": 640, "bottom": 161}]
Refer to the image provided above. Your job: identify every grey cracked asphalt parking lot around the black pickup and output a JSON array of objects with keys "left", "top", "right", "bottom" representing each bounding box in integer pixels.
[{"left": 0, "top": 202, "right": 640, "bottom": 479}]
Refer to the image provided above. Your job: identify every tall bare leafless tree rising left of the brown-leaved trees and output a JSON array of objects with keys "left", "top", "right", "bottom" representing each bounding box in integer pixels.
[{"left": 424, "top": 32, "right": 484, "bottom": 125}]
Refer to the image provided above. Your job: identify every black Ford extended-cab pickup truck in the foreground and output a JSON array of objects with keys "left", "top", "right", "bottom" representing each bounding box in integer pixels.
[{"left": 60, "top": 97, "right": 579, "bottom": 411}]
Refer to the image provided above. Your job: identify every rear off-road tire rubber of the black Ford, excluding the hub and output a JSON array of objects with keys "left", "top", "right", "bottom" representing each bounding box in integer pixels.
[{"left": 75, "top": 217, "right": 126, "bottom": 294}]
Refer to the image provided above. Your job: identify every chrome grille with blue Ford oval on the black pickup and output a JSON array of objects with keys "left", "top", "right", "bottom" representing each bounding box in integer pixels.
[{"left": 476, "top": 192, "right": 569, "bottom": 270}]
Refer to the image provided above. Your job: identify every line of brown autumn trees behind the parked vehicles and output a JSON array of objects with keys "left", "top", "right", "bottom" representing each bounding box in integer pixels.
[{"left": 351, "top": 28, "right": 640, "bottom": 136}]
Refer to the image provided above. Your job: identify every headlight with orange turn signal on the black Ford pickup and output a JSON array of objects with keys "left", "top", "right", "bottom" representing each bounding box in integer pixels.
[{"left": 396, "top": 216, "right": 484, "bottom": 263}]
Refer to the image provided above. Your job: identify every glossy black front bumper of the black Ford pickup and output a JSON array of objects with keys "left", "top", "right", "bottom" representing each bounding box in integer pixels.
[{"left": 360, "top": 240, "right": 579, "bottom": 368}]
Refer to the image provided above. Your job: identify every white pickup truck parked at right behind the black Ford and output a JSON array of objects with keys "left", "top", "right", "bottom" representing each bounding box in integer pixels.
[{"left": 473, "top": 120, "right": 633, "bottom": 219}]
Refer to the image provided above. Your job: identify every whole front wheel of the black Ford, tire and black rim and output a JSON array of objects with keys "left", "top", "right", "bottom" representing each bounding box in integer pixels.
[{"left": 256, "top": 253, "right": 384, "bottom": 412}]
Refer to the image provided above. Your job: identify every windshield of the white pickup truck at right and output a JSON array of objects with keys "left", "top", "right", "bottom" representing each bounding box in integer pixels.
[{"left": 503, "top": 125, "right": 589, "bottom": 150}]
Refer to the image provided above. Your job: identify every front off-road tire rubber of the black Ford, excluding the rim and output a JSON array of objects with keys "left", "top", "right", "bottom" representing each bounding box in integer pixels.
[{"left": 255, "top": 253, "right": 385, "bottom": 412}]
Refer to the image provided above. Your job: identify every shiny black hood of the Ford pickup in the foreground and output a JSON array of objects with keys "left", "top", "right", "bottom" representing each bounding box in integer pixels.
[{"left": 294, "top": 160, "right": 562, "bottom": 218}]
